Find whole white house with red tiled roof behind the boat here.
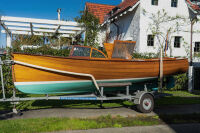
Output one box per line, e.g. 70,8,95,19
85,0,200,90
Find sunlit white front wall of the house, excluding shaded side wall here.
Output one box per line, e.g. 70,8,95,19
138,0,200,56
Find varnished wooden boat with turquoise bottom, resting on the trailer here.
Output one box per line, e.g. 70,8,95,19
13,43,188,94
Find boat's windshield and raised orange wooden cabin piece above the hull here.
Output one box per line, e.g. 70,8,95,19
64,40,136,60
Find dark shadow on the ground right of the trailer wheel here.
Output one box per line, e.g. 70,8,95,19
154,92,200,133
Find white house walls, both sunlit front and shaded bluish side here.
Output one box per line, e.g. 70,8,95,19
104,0,200,57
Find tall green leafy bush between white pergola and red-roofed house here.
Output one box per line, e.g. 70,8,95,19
75,10,100,47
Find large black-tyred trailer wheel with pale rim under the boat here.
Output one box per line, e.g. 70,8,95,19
137,94,154,113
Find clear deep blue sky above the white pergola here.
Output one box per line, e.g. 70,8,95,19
0,0,122,20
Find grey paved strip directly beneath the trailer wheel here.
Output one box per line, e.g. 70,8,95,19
0,104,200,120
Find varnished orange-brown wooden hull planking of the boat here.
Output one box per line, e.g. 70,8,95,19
13,54,188,94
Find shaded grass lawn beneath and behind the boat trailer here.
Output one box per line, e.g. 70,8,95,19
0,91,200,110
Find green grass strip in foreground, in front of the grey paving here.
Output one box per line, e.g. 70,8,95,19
0,114,200,133
